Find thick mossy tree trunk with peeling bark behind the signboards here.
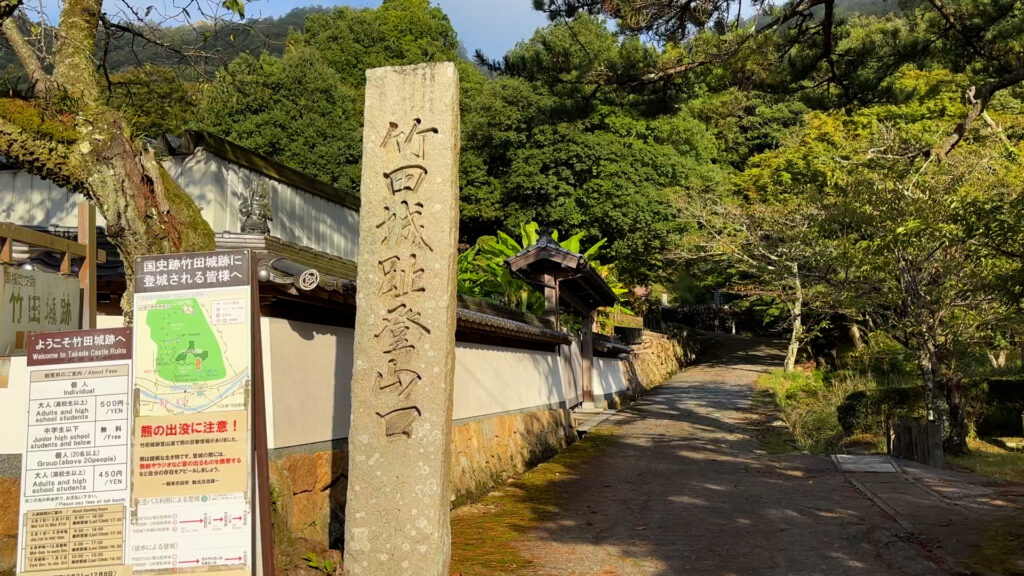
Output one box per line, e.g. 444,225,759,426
0,0,213,323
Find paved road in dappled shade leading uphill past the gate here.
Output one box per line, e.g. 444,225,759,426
521,339,929,576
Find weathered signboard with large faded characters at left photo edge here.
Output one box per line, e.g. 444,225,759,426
0,266,82,356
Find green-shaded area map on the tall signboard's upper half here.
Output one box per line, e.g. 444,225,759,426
135,288,251,416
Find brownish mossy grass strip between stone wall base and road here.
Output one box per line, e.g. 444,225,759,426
452,428,612,576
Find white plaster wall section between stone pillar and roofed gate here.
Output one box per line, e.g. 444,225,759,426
453,343,565,420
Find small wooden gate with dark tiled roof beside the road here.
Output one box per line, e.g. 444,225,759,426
506,232,618,403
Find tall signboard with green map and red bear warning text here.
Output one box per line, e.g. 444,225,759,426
131,250,253,575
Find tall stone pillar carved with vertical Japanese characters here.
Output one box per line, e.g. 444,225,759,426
344,63,460,576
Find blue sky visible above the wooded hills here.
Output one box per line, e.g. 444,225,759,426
246,0,548,58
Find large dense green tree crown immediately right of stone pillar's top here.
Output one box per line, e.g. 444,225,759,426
462,16,724,283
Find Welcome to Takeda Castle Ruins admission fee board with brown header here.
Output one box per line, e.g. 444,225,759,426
17,328,132,576
